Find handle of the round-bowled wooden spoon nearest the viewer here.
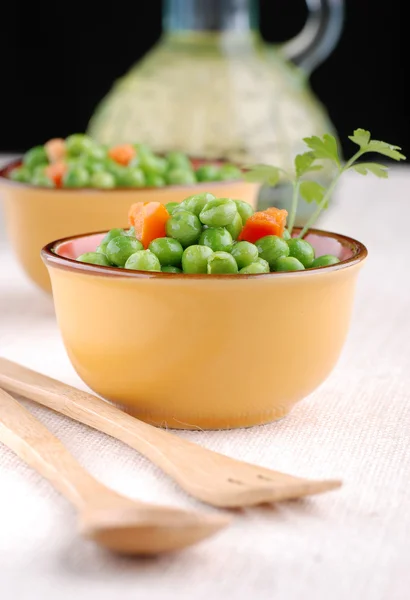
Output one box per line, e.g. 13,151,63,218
0,389,110,509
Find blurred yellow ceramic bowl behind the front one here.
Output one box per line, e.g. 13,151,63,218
0,162,259,291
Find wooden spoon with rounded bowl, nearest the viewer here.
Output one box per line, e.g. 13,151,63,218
0,389,229,554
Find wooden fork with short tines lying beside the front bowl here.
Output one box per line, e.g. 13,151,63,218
0,358,341,507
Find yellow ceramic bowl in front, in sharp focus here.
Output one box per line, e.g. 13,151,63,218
42,231,367,429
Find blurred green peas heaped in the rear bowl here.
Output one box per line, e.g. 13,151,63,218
9,134,242,189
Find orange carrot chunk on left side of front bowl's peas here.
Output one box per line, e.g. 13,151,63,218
128,202,170,248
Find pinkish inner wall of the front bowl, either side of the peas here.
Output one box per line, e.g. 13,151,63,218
54,233,358,261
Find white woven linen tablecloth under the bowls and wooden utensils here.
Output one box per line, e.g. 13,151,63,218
0,167,410,600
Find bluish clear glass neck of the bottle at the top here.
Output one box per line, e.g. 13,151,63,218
164,0,259,34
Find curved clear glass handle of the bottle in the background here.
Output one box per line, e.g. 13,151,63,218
281,0,345,75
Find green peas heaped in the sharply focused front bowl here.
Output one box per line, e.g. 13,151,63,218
77,193,339,275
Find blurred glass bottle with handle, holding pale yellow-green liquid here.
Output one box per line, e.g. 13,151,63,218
89,0,343,222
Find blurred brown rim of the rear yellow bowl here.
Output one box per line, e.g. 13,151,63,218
0,156,253,195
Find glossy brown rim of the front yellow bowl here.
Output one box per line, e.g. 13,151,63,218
41,227,368,281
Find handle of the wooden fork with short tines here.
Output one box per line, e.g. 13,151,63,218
0,358,187,480
